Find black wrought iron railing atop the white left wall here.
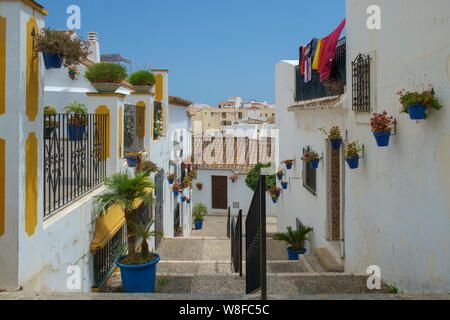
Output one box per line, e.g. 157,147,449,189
43,114,109,216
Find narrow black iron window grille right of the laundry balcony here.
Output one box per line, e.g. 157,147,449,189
352,53,371,112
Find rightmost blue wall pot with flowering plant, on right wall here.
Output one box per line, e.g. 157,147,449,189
397,89,442,120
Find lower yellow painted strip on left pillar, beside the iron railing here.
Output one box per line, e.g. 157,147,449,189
25,132,38,237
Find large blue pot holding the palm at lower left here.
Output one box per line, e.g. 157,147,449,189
116,253,160,293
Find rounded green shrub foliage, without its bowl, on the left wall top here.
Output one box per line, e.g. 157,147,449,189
84,62,127,83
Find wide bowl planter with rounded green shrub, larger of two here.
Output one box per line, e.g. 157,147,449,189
84,62,127,93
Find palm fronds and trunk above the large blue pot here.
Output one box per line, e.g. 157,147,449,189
94,171,154,265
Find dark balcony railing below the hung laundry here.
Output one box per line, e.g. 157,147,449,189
295,38,347,102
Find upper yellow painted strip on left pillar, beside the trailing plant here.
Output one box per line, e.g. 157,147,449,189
26,17,39,122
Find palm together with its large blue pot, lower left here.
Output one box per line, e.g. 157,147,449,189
94,172,160,293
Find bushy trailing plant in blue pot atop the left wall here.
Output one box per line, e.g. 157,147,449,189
34,28,90,69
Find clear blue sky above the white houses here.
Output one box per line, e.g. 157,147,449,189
38,0,345,106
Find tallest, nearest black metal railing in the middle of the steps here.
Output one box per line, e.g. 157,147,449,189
245,176,267,300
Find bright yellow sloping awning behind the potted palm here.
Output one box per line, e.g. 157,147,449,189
91,189,153,251
